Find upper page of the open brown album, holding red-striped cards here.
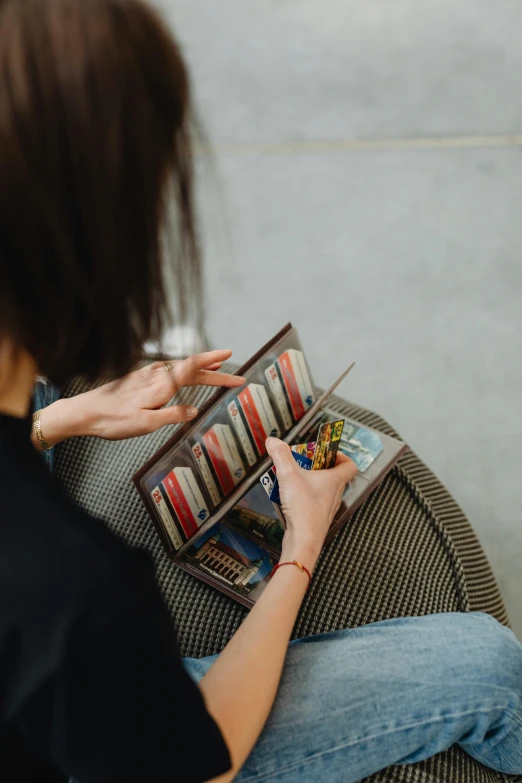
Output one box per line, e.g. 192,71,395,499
133,324,353,561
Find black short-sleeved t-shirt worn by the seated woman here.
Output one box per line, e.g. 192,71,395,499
0,415,230,783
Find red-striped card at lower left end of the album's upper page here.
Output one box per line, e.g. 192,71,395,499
152,468,209,549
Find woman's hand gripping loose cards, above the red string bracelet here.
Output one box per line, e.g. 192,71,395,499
266,438,357,571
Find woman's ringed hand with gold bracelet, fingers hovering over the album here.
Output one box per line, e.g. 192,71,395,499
36,350,245,446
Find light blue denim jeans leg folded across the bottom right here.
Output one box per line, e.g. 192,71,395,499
184,613,522,783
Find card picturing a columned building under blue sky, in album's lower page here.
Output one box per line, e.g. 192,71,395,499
185,523,274,596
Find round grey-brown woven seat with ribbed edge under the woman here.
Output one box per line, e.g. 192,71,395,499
56,380,522,783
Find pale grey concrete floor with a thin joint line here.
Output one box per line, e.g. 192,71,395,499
162,0,522,638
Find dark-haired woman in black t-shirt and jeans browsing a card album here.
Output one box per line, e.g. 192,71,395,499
0,0,522,783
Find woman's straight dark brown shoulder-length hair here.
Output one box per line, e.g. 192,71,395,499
0,0,201,383
